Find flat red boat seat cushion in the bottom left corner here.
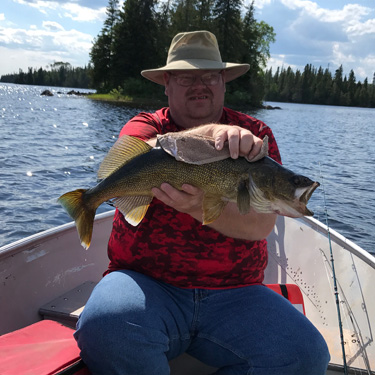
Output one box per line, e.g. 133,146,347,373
0,320,89,375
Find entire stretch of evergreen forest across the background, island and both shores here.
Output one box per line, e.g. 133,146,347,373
0,0,375,108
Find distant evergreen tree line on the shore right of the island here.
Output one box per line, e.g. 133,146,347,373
264,64,375,108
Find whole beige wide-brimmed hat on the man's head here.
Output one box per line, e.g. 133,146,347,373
141,31,250,85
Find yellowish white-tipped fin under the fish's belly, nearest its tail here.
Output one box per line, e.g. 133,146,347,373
113,195,152,226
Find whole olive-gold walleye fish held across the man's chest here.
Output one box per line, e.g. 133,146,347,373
58,132,319,249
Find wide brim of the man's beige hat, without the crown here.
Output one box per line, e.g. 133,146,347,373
141,59,250,86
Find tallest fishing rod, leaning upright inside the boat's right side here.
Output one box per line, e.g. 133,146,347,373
319,163,348,375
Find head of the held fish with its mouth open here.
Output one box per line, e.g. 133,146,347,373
250,158,320,217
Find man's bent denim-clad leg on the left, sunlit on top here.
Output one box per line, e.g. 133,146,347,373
74,273,177,375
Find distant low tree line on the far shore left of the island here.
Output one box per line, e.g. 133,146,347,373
0,62,92,88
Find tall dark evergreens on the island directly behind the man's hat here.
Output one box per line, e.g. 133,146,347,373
90,0,275,106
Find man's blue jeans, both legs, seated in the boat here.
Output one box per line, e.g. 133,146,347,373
75,271,329,375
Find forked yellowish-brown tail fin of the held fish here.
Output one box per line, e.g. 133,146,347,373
57,189,97,250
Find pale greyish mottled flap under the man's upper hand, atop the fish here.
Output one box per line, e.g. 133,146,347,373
157,132,268,165
